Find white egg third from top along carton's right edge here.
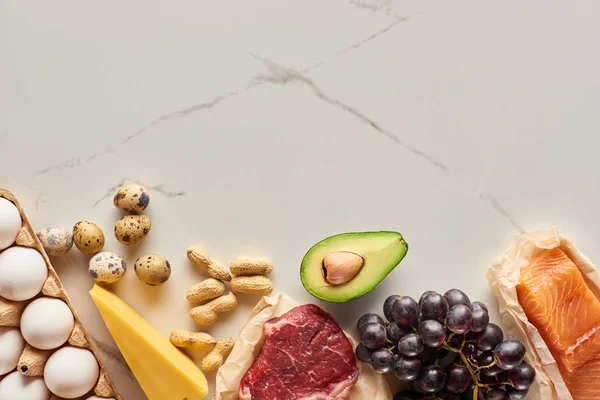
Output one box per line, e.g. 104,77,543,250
21,297,75,350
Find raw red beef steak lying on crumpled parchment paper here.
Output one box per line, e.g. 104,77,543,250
239,304,358,400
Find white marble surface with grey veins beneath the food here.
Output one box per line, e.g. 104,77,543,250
0,0,600,400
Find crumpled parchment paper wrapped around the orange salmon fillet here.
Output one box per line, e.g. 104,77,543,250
486,228,600,400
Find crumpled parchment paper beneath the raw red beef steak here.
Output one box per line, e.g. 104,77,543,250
215,293,392,400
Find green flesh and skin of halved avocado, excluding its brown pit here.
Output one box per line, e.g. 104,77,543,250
300,231,408,303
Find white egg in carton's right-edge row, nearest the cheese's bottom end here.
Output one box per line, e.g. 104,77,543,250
43,346,100,400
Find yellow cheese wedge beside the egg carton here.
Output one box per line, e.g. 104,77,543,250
90,285,208,400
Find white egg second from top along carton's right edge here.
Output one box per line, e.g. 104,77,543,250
0,246,48,301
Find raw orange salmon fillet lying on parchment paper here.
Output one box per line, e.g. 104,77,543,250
517,248,600,400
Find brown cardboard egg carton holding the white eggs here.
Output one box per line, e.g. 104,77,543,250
0,188,123,400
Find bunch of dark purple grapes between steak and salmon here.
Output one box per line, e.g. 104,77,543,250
356,289,535,400
